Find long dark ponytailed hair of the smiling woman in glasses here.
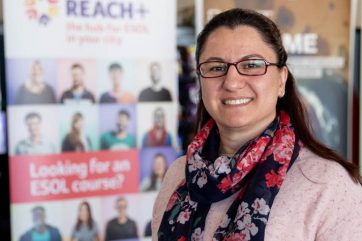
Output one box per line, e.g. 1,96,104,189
196,8,362,184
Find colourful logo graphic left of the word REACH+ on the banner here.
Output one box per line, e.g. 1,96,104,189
24,0,59,25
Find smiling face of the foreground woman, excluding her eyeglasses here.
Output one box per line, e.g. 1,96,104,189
199,26,288,132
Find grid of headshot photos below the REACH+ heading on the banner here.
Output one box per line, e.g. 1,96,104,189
7,59,179,241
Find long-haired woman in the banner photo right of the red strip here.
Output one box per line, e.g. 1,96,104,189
141,153,167,192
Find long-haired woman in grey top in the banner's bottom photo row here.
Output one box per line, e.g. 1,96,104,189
72,201,100,241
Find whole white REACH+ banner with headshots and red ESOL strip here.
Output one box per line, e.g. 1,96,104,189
4,0,180,241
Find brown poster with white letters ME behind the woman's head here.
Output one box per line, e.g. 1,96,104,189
202,0,351,157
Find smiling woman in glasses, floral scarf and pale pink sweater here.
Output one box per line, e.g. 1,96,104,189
152,9,362,241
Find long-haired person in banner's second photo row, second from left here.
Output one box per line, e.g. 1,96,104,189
62,112,92,152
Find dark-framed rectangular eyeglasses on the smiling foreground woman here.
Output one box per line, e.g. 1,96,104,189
197,59,279,78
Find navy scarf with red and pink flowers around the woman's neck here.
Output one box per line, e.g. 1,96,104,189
158,111,301,241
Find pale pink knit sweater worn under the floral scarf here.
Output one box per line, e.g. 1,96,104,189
152,148,362,241
